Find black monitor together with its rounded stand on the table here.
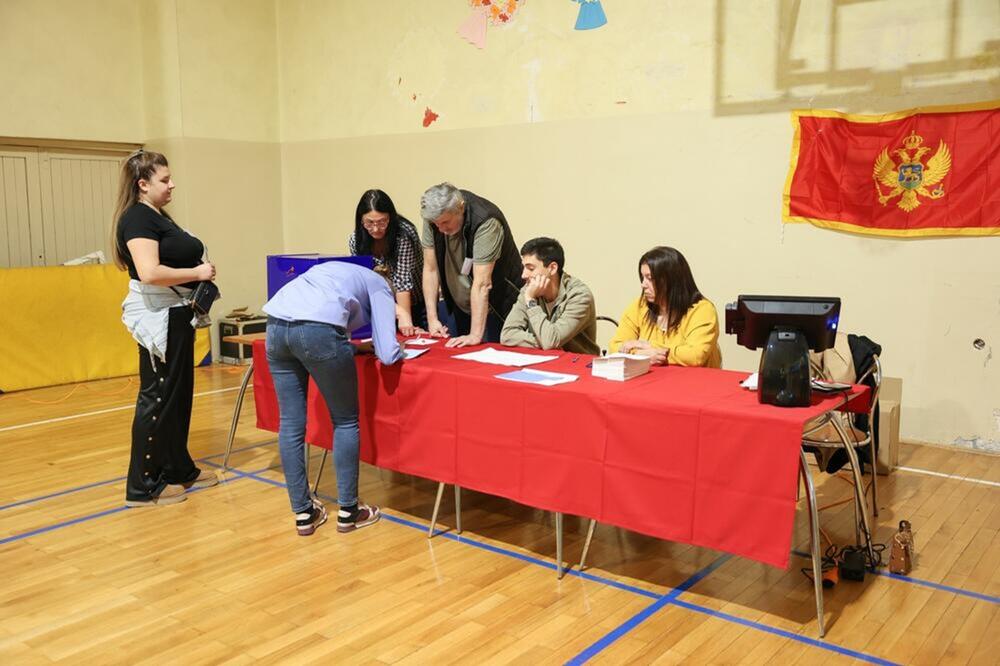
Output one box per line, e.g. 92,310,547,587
726,296,840,407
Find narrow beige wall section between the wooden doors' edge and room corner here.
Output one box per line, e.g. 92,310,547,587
140,0,284,350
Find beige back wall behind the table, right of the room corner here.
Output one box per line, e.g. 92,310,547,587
278,0,1000,449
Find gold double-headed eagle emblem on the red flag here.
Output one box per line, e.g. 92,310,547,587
872,132,951,213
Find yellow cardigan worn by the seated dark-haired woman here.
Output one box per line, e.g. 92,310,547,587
608,296,722,368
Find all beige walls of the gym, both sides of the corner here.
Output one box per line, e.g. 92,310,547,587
0,0,1000,447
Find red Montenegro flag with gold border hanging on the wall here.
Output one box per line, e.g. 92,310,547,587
783,101,1000,236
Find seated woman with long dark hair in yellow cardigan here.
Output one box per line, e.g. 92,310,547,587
608,247,722,368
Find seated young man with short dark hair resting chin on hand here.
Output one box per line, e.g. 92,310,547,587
500,237,601,356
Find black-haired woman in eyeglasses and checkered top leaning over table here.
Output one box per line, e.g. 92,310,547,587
348,190,427,336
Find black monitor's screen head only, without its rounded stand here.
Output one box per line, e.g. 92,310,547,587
726,296,840,352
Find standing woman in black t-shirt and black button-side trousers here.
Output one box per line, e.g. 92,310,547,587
111,150,218,506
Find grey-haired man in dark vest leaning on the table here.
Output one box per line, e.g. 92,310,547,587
420,183,521,347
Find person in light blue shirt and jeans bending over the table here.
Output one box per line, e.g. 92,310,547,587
264,261,403,536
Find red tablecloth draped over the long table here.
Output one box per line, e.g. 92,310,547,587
254,341,867,567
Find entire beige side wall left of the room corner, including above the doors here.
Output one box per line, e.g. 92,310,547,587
0,0,283,349
